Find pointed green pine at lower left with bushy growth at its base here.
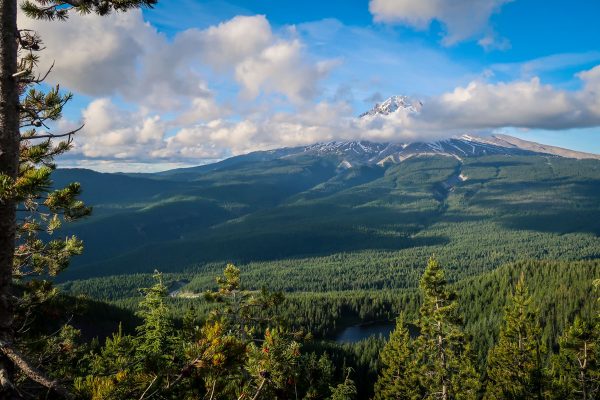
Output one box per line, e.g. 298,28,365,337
75,272,185,400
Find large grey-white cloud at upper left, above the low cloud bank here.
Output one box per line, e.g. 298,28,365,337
19,10,332,108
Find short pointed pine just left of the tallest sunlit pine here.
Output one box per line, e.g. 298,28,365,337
374,314,423,400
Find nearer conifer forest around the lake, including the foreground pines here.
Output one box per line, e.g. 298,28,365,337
12,258,600,399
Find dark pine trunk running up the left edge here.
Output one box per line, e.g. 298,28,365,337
0,0,19,376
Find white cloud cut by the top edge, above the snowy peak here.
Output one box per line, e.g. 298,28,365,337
369,0,512,48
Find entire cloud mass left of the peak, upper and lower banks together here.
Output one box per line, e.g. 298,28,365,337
19,11,335,169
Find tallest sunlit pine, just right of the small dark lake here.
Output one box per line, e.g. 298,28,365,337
416,257,479,400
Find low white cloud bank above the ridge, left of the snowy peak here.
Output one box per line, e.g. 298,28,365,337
67,98,352,164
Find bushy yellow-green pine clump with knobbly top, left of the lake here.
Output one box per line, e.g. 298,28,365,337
193,264,330,399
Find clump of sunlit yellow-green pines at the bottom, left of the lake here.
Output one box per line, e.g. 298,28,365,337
74,265,355,400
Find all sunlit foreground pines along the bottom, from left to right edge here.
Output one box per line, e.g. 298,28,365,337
3,258,600,400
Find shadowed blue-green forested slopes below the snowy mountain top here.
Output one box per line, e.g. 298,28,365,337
56,156,600,282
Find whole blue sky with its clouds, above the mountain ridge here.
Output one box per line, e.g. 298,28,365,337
20,0,600,170
